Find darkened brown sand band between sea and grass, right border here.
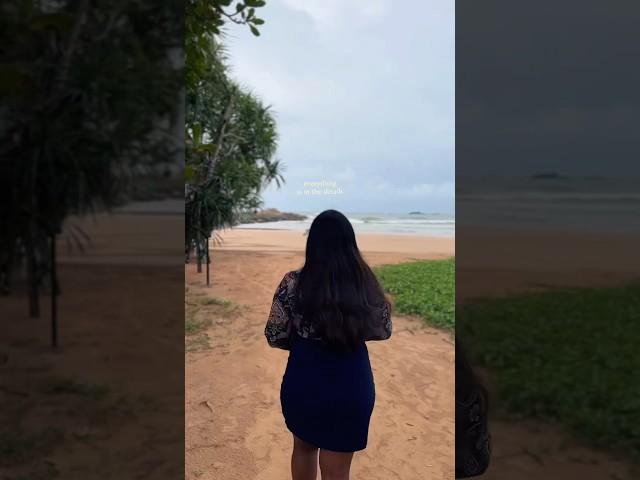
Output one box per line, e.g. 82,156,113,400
456,228,640,303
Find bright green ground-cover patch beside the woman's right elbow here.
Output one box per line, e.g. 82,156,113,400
374,258,455,332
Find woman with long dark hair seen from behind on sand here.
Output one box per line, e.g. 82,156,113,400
265,210,391,480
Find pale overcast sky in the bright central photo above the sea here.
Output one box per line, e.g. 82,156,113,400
225,0,455,213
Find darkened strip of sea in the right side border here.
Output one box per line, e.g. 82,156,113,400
456,175,640,232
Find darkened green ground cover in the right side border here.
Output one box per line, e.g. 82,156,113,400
457,285,640,458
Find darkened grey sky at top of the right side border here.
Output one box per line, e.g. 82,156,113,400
456,0,640,176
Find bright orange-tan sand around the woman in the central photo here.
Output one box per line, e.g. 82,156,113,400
185,230,454,480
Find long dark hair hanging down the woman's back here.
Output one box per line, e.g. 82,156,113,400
296,210,386,350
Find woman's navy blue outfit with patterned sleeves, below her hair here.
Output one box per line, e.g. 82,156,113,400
265,271,391,452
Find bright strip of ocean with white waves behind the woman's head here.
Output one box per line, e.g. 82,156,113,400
235,212,455,237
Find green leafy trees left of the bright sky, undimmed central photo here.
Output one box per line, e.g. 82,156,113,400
185,0,284,266
